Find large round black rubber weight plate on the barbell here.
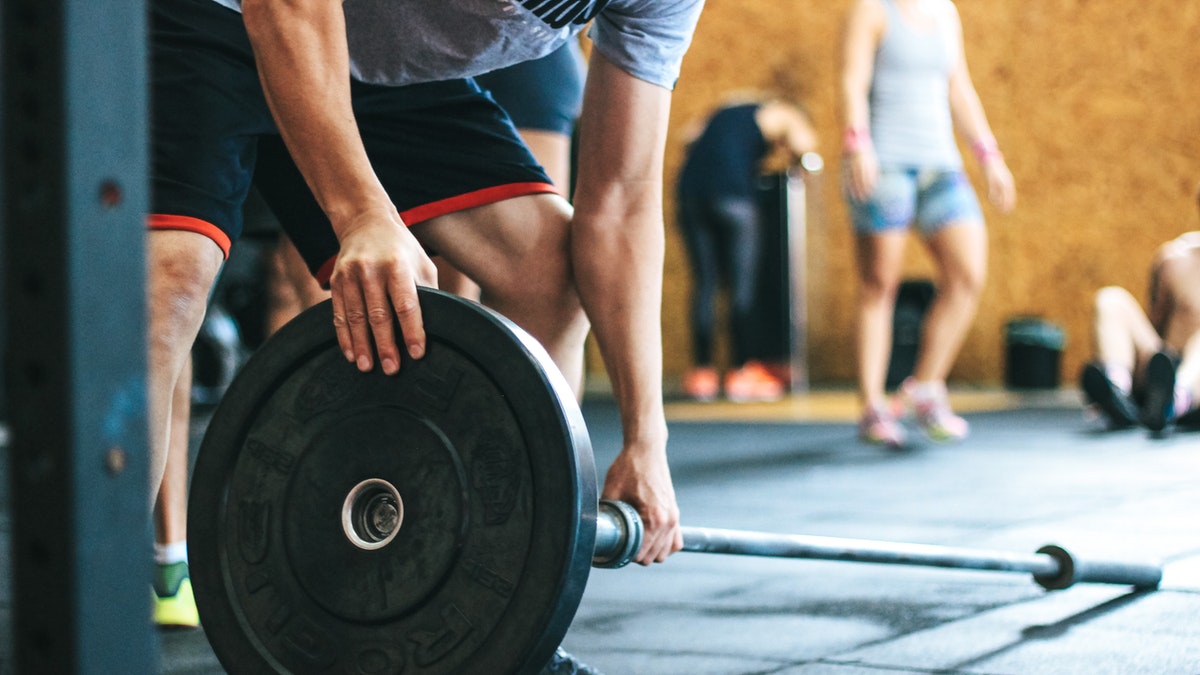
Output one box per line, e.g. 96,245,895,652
187,288,596,675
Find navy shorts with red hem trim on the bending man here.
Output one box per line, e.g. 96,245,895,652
149,0,554,283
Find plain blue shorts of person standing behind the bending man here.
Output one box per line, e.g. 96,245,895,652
475,40,584,136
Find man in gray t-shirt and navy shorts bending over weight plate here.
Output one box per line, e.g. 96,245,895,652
148,0,702,662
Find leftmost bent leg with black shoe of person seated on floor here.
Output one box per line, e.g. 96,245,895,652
1080,286,1163,429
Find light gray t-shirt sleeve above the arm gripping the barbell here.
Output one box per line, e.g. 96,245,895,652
588,0,704,89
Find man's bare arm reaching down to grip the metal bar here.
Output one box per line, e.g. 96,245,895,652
571,50,683,565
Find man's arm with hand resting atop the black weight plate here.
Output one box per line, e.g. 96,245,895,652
242,0,437,374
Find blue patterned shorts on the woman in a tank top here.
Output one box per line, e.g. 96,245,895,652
846,166,983,237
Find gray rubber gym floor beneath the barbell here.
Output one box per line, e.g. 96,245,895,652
0,390,1200,675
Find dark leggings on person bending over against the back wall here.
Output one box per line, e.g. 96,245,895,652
679,198,761,366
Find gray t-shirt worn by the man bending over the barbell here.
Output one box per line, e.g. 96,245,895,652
207,0,704,89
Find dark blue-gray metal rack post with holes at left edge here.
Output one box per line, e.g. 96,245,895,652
0,0,158,674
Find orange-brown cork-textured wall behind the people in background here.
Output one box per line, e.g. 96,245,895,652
628,0,1200,386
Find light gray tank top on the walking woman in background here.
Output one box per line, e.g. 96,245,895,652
870,0,962,168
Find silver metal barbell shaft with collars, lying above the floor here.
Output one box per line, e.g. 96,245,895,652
593,501,1163,590
